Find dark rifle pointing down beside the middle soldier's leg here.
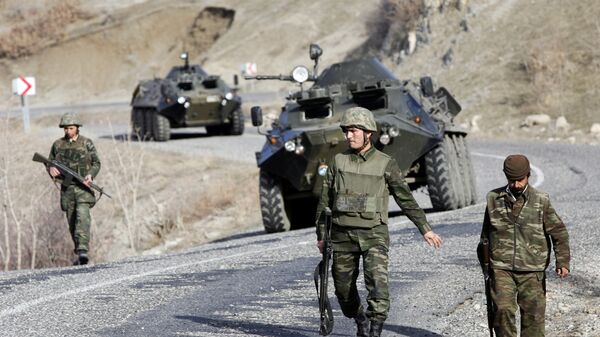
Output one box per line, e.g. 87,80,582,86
314,207,333,336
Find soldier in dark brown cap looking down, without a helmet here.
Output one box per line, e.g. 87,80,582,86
479,155,570,337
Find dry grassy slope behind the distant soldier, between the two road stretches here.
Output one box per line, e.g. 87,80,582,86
0,113,260,270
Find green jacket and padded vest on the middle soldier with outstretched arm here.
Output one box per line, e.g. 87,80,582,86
316,147,431,240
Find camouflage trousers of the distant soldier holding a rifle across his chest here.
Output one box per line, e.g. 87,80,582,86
60,185,96,253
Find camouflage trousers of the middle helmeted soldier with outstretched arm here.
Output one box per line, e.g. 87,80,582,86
331,226,390,322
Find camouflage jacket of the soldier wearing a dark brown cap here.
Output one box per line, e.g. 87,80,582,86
480,185,571,271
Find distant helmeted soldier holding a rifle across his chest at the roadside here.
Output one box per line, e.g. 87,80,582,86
47,113,100,264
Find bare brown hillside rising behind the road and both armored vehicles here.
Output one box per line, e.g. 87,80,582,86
0,0,600,143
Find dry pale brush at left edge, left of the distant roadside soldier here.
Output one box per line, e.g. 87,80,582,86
0,118,73,270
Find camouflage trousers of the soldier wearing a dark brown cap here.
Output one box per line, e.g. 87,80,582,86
491,269,546,337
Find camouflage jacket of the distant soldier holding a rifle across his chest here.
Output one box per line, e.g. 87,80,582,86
48,135,100,178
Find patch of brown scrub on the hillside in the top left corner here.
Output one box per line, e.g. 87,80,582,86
0,1,89,59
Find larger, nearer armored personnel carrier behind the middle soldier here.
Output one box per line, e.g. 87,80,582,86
245,45,477,232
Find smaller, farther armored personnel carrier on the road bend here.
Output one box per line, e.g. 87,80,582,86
131,53,244,141
